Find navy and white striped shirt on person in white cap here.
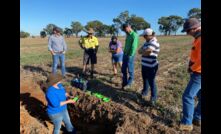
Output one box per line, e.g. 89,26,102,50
141,37,160,68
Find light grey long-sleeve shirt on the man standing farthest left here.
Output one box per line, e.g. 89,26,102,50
48,35,67,52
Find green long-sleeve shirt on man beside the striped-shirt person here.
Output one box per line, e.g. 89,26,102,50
124,31,139,56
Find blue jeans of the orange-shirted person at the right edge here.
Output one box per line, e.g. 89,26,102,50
181,73,201,125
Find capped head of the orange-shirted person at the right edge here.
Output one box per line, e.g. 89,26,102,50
182,18,201,36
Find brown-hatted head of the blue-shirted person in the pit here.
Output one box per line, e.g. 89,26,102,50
46,73,63,87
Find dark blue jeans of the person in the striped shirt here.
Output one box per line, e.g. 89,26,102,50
142,65,158,101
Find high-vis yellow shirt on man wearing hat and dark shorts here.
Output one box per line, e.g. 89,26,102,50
82,36,98,49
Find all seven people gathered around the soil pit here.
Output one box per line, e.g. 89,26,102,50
46,18,201,133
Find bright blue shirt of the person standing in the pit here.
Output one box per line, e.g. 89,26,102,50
45,84,67,115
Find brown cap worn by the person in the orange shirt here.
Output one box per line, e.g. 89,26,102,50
181,18,201,32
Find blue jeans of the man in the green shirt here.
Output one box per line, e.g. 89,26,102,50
121,55,134,87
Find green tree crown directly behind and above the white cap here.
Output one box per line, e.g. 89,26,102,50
128,15,150,31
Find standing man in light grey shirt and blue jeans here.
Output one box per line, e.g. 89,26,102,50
48,27,67,77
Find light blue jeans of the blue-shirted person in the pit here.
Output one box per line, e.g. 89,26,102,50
49,109,76,134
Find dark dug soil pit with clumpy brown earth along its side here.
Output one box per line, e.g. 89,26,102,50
68,90,152,134
